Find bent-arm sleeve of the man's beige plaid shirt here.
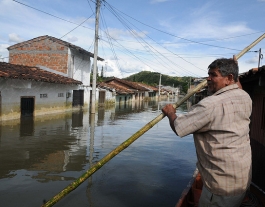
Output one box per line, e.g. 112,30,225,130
174,101,214,137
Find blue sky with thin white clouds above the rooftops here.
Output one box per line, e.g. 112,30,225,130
0,0,265,78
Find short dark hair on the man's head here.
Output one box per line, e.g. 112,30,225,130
208,58,238,82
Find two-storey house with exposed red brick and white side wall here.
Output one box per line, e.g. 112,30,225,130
8,35,104,108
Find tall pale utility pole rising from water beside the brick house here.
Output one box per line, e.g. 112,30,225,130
90,0,100,114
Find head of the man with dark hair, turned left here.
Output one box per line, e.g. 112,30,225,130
207,58,238,93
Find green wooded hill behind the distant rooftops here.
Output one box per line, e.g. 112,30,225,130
123,71,190,93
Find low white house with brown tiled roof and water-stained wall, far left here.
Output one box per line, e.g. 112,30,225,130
0,62,82,121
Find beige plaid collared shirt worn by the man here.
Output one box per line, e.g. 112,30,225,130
174,84,252,196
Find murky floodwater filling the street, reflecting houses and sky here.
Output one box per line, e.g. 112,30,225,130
0,100,196,207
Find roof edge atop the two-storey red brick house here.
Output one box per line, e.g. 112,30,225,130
7,35,104,61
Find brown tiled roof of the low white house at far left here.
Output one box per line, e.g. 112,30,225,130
0,62,82,85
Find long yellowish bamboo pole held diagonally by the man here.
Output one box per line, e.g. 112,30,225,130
42,33,265,207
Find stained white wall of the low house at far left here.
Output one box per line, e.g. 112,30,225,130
0,78,78,120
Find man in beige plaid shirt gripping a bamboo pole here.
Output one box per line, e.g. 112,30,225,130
162,58,252,207
